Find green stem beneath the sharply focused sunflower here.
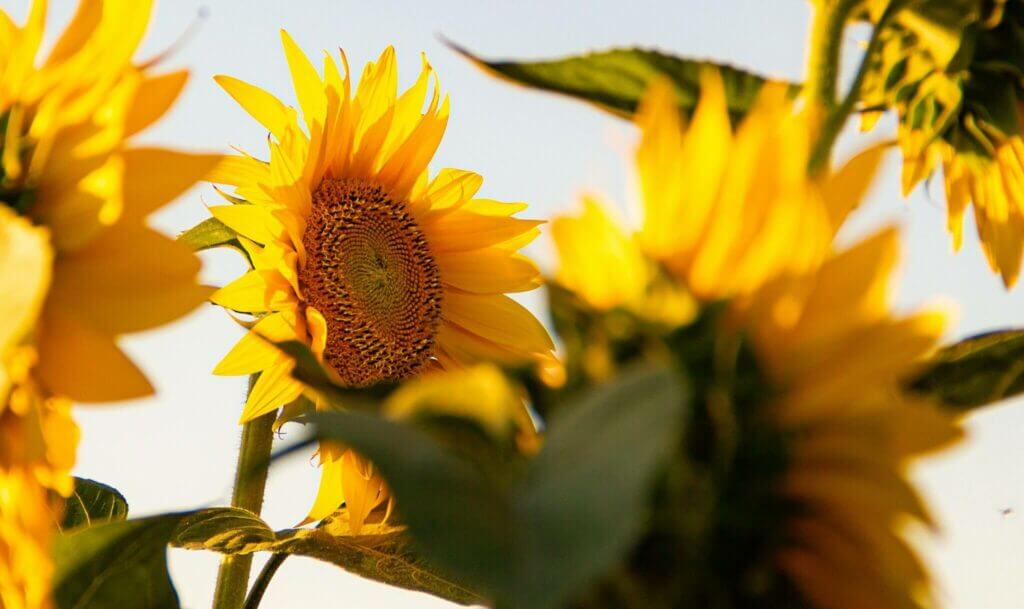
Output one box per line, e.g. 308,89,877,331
213,376,275,609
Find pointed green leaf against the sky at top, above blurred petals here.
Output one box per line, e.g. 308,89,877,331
452,45,800,122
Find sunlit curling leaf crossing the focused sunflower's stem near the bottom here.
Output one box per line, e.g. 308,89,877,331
171,508,482,605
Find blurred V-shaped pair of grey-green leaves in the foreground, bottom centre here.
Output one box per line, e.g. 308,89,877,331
313,369,686,609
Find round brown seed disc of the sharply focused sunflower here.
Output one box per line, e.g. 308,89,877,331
299,179,443,387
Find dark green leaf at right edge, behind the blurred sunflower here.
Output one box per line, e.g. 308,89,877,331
908,330,1024,411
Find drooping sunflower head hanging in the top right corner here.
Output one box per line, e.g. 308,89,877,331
861,0,1024,288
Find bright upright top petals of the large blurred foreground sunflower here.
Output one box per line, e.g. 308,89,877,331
552,70,883,311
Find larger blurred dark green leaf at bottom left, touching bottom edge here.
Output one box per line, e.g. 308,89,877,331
53,514,187,609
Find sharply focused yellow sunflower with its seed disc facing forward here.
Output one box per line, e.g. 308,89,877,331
210,32,553,526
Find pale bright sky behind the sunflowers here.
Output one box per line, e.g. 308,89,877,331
9,0,1024,609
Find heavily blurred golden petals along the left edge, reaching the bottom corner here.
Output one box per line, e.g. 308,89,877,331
0,207,77,609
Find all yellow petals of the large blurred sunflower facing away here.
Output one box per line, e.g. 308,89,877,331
554,73,961,609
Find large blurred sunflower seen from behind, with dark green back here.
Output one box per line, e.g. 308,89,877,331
555,73,961,609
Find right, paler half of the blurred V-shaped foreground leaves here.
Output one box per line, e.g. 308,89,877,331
509,364,687,608
